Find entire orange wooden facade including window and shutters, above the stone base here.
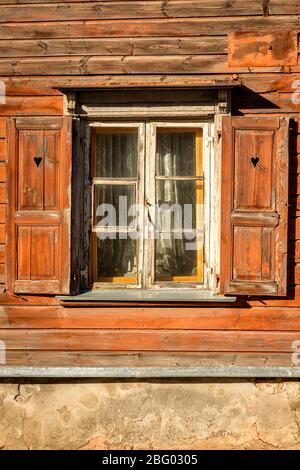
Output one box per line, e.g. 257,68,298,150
0,0,300,376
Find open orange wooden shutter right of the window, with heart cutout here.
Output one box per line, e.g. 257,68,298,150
220,117,289,295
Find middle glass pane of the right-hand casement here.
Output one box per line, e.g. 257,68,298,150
156,180,203,230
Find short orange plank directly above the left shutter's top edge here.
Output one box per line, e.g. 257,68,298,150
0,96,63,116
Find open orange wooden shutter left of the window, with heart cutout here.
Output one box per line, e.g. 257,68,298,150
7,117,71,294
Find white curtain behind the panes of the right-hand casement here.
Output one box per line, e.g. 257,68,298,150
155,132,197,276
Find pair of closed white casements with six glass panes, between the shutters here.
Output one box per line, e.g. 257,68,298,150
90,122,212,289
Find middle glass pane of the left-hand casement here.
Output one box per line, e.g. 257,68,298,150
94,184,135,227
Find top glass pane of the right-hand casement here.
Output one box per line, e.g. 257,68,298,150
156,129,202,176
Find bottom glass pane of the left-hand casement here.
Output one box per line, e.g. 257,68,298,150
95,233,137,282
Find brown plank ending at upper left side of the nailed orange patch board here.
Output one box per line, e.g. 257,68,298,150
0,36,227,57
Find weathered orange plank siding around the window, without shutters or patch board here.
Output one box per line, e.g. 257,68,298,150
0,0,300,366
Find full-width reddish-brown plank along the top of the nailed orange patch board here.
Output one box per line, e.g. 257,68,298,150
0,17,299,40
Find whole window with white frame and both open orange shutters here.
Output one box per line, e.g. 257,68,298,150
6,90,289,301
